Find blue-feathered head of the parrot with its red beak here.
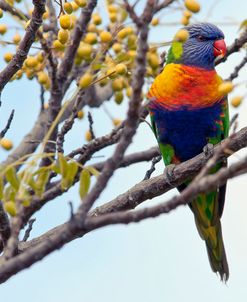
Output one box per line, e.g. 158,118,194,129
170,23,226,70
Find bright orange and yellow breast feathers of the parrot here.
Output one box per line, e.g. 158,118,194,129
148,63,225,109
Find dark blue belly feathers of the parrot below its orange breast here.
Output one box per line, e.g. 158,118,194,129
150,103,222,161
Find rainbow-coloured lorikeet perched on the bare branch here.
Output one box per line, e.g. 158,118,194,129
148,23,229,281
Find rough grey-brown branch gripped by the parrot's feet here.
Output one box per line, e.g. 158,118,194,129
19,127,247,251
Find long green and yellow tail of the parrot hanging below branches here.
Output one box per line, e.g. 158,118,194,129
190,192,229,281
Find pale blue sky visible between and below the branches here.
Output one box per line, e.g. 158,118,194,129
0,0,247,302
